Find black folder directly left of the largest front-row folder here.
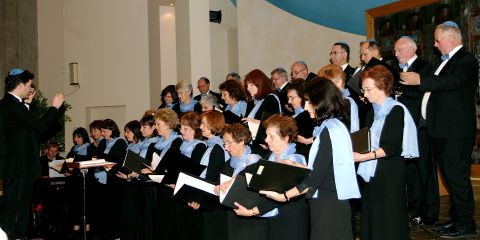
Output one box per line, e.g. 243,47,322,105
221,175,262,209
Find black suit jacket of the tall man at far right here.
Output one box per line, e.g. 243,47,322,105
420,47,478,138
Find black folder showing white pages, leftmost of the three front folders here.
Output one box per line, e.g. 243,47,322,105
173,172,219,210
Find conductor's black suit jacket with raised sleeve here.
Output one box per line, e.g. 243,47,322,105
0,93,61,179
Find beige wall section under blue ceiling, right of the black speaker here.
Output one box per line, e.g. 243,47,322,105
237,0,365,75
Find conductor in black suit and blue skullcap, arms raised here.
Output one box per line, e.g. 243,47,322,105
0,68,64,239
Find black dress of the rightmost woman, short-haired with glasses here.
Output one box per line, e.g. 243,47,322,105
360,106,410,240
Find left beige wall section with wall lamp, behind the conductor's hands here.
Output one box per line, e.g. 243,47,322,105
38,0,150,148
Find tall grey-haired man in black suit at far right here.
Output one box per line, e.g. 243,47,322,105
401,21,478,238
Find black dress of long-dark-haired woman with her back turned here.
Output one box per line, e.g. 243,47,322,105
297,128,352,240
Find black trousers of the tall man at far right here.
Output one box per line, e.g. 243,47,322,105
430,137,476,231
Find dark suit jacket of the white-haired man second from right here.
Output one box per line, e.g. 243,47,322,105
395,58,431,126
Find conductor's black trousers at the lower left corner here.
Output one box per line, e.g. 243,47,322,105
0,178,35,239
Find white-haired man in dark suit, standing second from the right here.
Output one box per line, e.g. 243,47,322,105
394,36,440,225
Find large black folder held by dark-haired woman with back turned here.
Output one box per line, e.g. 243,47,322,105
248,159,311,193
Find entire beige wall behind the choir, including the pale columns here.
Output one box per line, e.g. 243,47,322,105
38,0,364,150
